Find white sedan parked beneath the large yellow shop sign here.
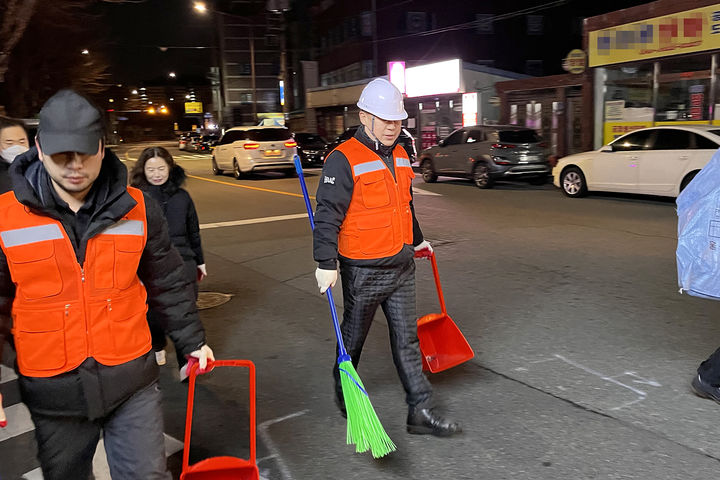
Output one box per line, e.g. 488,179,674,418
553,125,720,197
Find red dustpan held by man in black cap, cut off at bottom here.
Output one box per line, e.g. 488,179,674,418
180,359,260,480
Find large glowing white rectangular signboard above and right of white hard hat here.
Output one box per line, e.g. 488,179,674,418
405,59,462,97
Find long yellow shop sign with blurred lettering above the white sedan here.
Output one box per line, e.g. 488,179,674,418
588,4,720,67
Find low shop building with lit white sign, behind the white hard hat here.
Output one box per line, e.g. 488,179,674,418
306,59,527,144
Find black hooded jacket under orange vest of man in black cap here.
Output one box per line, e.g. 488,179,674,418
0,148,205,418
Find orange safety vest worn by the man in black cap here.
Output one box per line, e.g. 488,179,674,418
0,187,152,377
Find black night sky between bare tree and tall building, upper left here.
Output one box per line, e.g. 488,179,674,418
98,0,214,85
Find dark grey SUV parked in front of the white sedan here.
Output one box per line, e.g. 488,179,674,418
418,125,550,188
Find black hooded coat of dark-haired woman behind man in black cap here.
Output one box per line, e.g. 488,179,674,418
133,165,205,265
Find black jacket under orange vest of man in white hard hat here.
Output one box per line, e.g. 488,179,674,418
313,126,423,270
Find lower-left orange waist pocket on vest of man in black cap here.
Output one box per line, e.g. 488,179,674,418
13,310,67,376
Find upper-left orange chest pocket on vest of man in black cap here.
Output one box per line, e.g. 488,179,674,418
6,240,63,300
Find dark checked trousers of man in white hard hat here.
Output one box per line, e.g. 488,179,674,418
333,261,433,408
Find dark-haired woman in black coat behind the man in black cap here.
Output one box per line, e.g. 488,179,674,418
130,147,207,365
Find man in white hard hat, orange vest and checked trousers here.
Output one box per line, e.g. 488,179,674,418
313,78,461,436
